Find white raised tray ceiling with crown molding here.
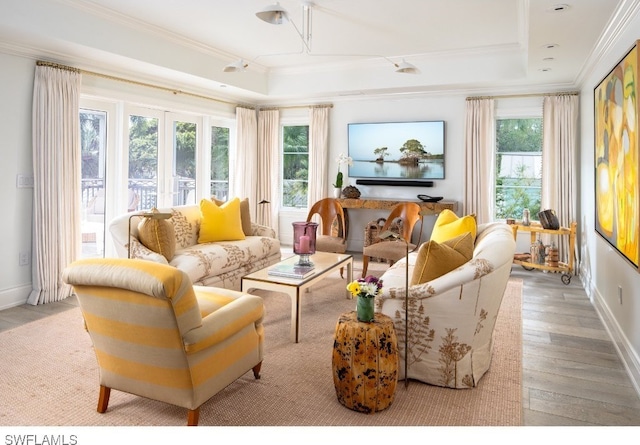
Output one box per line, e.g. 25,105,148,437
0,0,639,103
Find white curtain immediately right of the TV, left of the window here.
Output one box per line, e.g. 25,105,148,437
462,98,496,223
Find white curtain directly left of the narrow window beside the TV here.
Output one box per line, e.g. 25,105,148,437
256,110,280,229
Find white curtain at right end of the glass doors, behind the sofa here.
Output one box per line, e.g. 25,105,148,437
231,107,258,222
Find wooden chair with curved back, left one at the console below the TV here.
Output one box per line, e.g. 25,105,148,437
307,198,347,277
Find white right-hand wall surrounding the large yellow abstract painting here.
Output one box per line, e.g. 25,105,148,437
578,13,640,392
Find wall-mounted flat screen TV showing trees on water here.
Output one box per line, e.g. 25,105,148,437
347,121,444,180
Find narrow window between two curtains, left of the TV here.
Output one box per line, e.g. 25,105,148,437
282,125,309,208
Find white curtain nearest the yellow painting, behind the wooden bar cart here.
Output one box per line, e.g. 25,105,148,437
541,94,579,258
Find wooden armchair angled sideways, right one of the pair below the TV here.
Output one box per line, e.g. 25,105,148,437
362,202,422,278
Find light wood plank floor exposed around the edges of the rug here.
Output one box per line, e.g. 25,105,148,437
0,266,640,426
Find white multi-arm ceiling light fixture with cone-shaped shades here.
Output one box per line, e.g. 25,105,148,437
224,1,420,74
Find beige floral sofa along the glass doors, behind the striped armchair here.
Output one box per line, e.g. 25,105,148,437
109,204,281,290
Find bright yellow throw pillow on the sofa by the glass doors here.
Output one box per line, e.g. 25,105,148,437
198,198,245,243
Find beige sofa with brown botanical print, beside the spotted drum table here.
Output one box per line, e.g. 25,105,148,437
376,223,516,388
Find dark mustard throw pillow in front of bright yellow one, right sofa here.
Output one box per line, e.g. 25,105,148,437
411,232,474,285
